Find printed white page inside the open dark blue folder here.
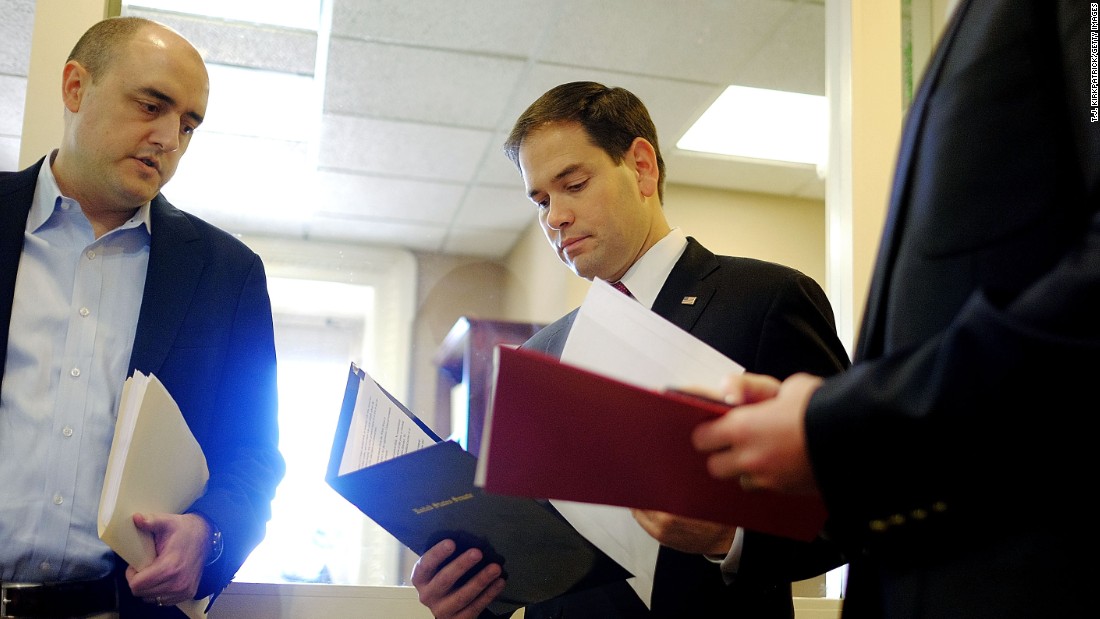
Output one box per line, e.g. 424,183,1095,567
340,368,436,475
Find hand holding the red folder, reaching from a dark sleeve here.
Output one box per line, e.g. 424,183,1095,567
692,374,822,494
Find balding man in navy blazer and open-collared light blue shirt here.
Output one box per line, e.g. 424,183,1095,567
0,18,284,619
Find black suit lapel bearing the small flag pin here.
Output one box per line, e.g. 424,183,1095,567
653,236,718,331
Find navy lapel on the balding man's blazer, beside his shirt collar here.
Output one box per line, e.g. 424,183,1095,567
130,195,204,373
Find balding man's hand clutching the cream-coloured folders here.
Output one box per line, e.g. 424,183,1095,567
127,513,211,606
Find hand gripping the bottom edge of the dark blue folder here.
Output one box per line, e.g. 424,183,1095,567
411,540,505,619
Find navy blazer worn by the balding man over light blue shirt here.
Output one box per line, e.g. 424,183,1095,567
0,161,284,619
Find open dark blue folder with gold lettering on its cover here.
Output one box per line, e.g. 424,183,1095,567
326,364,631,615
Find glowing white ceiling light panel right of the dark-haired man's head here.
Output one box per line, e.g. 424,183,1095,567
677,86,828,166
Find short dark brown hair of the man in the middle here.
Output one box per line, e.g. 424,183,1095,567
504,81,664,202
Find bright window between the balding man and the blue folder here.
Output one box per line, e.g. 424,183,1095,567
237,239,416,585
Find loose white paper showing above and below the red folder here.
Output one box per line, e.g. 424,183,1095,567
551,279,745,607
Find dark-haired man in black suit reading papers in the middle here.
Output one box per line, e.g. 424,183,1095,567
413,81,848,619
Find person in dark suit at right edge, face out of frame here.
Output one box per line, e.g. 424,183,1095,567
693,0,1100,619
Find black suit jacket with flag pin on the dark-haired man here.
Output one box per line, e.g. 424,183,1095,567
524,237,848,619
